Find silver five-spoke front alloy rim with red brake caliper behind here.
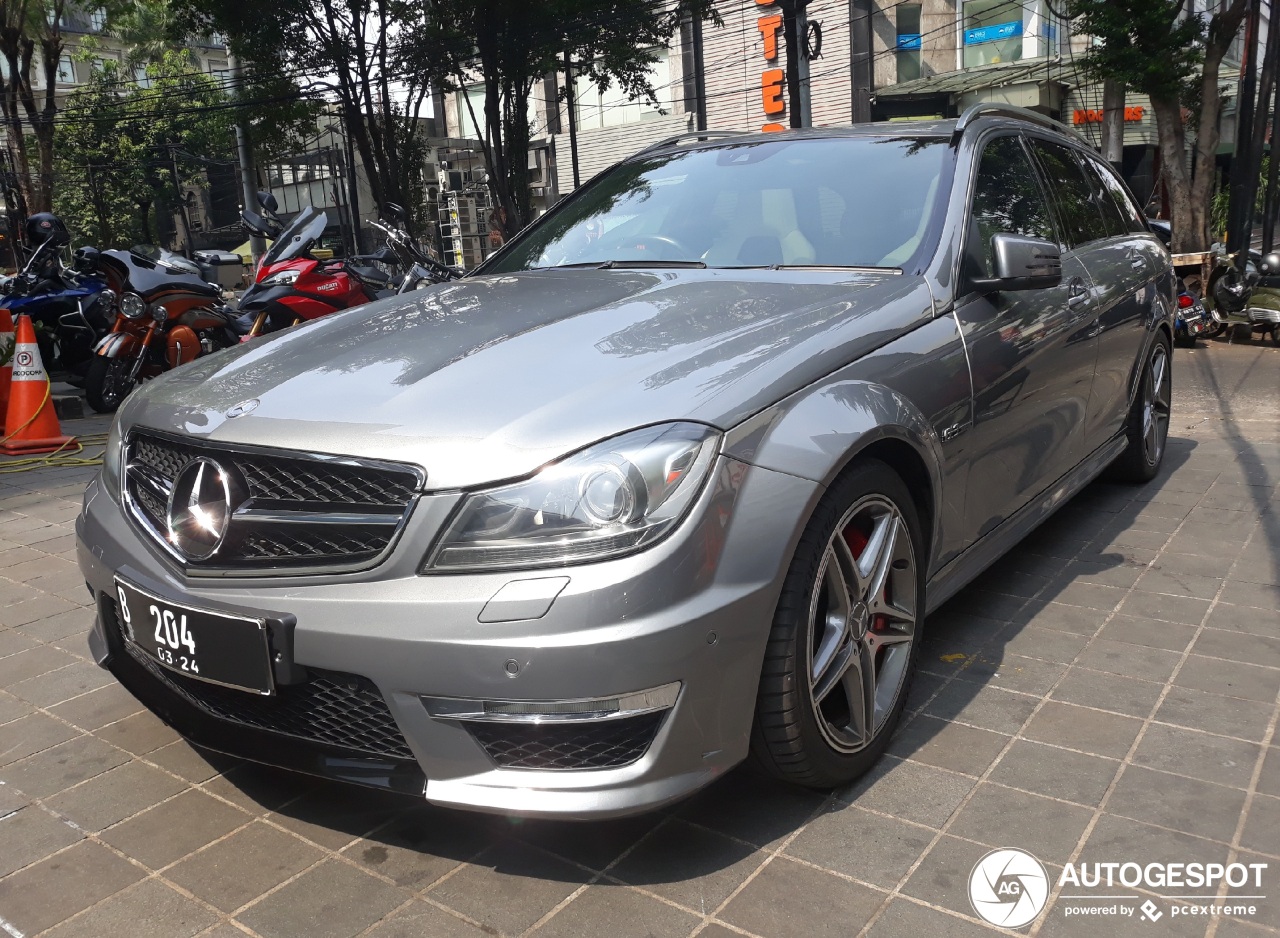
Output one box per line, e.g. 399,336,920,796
808,495,916,752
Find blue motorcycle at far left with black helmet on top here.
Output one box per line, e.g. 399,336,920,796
0,212,115,383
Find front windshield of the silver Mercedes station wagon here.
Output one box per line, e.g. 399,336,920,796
485,137,950,273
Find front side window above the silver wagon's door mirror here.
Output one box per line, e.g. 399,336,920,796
968,137,1057,278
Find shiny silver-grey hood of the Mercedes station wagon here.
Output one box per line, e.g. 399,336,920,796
122,270,932,489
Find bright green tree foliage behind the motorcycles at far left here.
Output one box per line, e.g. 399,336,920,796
54,52,234,247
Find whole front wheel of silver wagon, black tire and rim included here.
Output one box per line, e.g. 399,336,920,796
751,459,927,788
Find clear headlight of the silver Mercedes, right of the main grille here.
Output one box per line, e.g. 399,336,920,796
424,424,719,572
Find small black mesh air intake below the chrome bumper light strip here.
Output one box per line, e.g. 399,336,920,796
463,711,666,770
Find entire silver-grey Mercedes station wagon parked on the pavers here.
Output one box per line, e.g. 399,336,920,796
77,106,1175,818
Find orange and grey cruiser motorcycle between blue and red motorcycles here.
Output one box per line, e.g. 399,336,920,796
84,241,247,413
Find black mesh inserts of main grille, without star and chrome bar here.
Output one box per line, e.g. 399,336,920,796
127,433,417,568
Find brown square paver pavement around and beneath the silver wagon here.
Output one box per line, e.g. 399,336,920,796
0,342,1280,938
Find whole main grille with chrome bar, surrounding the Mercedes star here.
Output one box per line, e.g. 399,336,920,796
125,430,420,576
